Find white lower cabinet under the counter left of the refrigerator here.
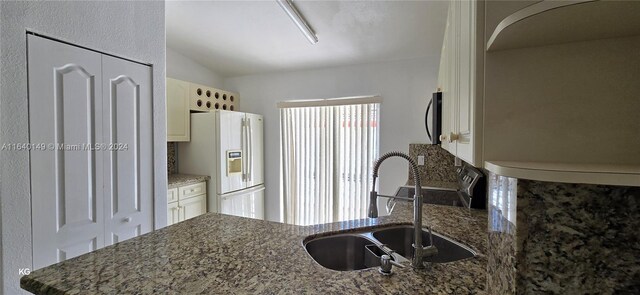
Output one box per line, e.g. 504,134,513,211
167,181,207,225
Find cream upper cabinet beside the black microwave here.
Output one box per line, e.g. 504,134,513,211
438,1,484,166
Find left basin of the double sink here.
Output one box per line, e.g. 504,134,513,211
304,234,379,271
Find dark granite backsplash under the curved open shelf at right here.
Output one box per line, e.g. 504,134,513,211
487,175,640,294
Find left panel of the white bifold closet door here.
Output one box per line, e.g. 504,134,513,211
27,35,104,269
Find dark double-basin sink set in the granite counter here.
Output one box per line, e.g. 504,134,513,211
303,225,476,271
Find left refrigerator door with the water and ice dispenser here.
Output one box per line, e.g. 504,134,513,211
216,111,247,194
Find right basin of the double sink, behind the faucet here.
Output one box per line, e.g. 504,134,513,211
373,225,476,263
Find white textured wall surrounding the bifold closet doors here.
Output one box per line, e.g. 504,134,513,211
0,1,167,294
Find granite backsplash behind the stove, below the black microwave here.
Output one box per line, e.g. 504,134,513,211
407,143,458,189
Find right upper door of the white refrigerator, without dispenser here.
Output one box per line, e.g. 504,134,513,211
245,113,264,187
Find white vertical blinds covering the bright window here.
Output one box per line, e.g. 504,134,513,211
280,103,380,225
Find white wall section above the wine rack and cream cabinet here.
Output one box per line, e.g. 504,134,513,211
167,47,223,88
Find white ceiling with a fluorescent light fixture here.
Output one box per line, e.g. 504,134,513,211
166,0,447,77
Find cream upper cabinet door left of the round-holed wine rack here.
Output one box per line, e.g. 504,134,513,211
167,78,191,141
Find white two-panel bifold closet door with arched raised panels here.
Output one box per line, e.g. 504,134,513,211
28,35,153,269
